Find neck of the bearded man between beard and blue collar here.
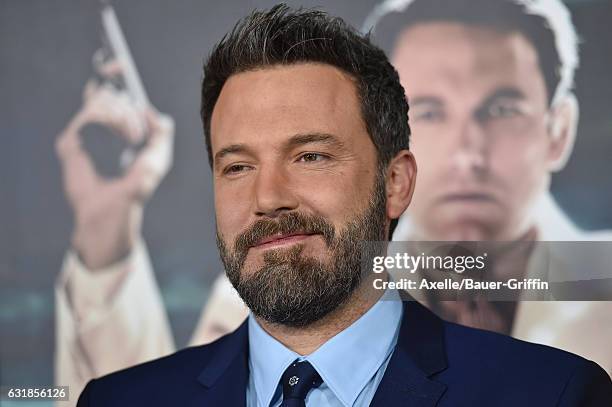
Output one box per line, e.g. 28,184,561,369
255,274,387,355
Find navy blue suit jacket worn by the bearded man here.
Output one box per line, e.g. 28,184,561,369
78,301,612,407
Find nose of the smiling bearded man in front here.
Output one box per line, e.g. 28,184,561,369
254,166,298,218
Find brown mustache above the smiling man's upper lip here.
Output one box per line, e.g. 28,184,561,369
234,212,335,253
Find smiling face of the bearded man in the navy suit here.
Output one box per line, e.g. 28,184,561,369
211,64,386,326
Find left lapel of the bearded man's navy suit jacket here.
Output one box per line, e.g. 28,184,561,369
193,321,249,407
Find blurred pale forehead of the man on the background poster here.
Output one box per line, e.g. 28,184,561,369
392,22,546,104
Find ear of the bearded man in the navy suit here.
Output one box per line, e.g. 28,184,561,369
386,150,417,219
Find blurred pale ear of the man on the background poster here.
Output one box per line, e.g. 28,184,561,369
548,93,579,172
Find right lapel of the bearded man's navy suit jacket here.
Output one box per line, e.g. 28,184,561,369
370,300,446,407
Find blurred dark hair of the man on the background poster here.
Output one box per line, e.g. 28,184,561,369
368,0,573,103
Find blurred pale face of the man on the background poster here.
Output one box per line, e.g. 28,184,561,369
392,23,551,240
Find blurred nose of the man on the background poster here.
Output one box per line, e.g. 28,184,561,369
451,120,490,176
